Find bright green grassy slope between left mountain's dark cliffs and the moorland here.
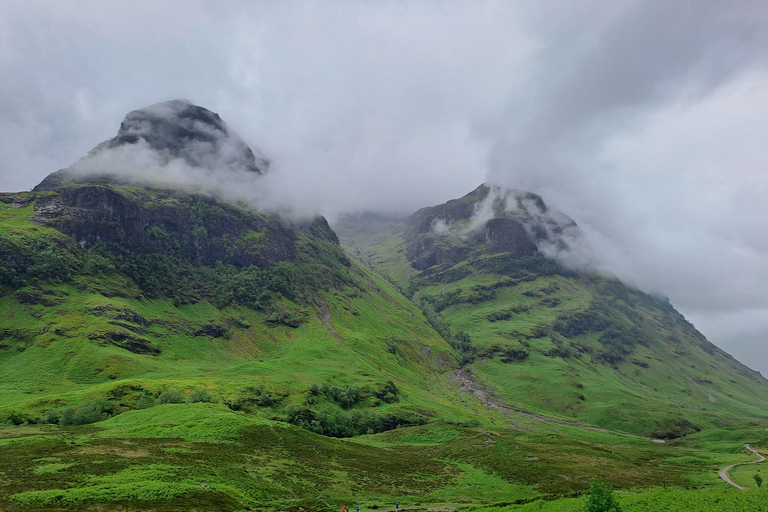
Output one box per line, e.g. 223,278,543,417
0,192,462,420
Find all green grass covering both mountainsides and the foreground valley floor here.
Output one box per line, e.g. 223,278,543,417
0,187,768,511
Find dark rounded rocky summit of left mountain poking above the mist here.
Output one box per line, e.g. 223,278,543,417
104,100,269,174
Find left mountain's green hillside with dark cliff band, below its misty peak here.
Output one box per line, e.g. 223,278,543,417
0,185,472,436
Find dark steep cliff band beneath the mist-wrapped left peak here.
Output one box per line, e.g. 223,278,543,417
25,184,302,267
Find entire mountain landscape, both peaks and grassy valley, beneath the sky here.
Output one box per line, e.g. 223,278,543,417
0,101,768,512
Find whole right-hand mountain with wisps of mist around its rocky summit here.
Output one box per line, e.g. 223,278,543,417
336,185,768,439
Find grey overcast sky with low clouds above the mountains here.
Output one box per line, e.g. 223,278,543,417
0,0,768,376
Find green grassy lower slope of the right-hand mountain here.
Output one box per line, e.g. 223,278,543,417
419,270,766,434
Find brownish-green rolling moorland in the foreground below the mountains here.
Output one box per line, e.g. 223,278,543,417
0,404,768,510
